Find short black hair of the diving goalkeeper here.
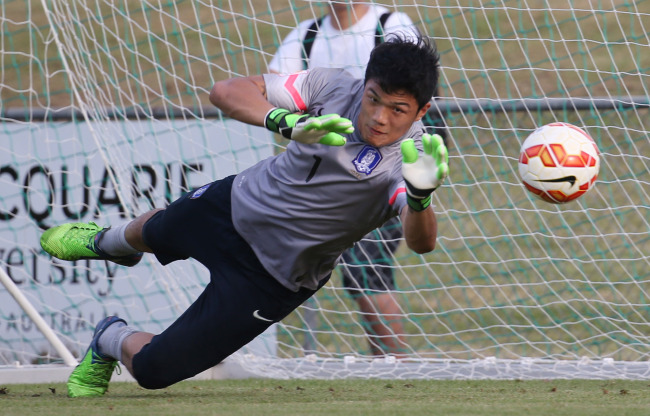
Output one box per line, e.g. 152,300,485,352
364,34,440,109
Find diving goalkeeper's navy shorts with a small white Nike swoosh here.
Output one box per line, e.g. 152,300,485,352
133,176,327,389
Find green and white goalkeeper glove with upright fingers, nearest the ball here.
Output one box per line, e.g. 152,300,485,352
401,134,449,211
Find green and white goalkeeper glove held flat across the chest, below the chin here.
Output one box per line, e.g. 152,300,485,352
264,108,354,146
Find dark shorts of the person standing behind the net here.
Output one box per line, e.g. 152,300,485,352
341,217,402,297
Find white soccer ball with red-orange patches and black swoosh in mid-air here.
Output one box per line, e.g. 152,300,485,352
519,123,600,204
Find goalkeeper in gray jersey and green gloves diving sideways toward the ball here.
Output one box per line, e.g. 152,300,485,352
41,36,448,397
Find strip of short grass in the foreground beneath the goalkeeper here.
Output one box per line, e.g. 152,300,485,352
0,379,650,416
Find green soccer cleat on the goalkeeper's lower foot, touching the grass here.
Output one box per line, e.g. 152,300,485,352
68,316,126,397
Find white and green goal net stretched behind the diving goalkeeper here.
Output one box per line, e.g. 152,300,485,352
0,0,650,378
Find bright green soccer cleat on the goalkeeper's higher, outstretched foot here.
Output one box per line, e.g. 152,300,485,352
41,222,142,267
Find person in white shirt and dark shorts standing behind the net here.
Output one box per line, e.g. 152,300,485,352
268,1,430,357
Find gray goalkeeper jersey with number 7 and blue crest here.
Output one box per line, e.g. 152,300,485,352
232,68,424,291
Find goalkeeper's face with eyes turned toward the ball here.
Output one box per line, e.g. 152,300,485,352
357,79,431,147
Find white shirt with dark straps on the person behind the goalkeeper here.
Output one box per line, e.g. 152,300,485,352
269,6,418,78
